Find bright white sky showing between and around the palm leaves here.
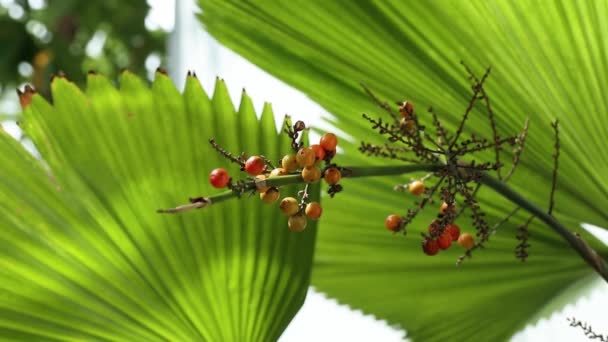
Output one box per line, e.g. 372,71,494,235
0,0,608,342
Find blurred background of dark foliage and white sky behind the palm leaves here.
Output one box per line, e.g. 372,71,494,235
0,0,608,341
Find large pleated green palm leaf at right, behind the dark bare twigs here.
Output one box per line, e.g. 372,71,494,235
200,1,608,341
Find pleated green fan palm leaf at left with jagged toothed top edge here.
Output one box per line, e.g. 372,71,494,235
0,73,318,341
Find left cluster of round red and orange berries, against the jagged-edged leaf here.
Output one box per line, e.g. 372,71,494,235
209,121,342,232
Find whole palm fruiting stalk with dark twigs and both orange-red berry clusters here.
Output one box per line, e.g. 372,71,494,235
159,66,608,281
